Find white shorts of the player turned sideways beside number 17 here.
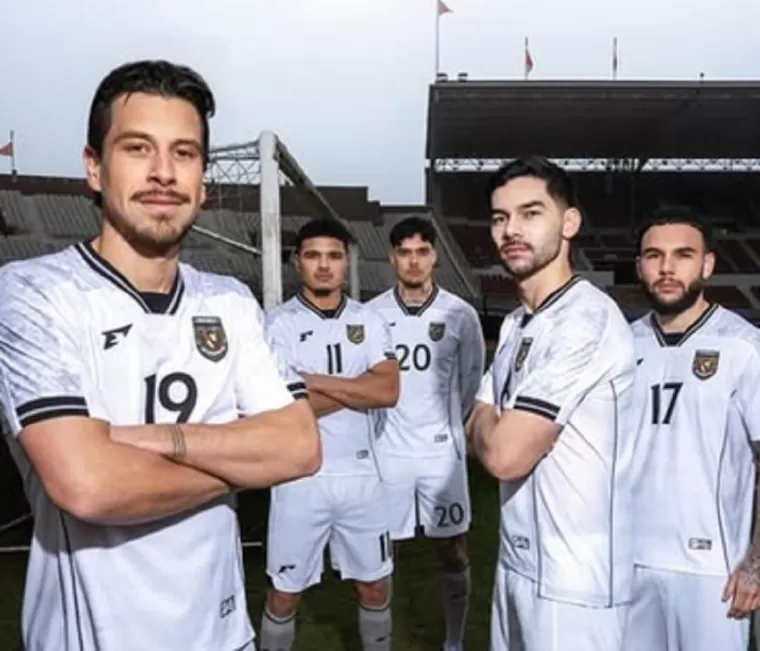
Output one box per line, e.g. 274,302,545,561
490,563,632,651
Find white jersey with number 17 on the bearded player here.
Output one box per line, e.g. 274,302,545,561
633,305,760,576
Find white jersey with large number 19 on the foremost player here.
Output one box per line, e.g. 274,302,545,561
0,244,305,651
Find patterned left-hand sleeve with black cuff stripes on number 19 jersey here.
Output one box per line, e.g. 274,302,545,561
0,273,90,436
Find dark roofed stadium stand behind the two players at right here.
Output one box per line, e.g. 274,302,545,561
427,80,760,321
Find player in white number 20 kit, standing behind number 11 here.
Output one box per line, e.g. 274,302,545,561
369,217,485,651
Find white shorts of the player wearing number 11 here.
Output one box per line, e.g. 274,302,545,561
267,476,393,593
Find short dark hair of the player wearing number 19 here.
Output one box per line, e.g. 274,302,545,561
87,61,216,166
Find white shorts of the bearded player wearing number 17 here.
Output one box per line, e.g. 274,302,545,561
624,567,750,651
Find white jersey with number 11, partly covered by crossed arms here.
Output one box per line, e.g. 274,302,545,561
266,294,395,476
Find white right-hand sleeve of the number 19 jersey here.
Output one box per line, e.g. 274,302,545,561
235,295,306,416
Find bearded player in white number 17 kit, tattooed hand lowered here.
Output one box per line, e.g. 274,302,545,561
626,207,760,651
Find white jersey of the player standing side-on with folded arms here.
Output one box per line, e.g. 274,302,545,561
478,277,636,607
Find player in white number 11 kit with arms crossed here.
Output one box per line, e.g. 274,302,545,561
261,220,399,651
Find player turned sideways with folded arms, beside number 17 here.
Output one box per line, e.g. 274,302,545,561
467,158,636,651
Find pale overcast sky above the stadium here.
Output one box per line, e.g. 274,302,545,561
0,0,760,203
